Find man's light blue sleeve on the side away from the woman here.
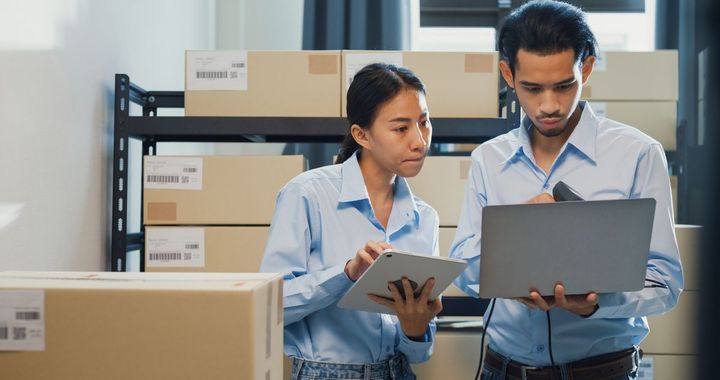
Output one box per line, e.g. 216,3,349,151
589,144,684,318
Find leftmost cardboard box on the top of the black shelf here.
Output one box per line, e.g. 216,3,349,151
185,50,340,117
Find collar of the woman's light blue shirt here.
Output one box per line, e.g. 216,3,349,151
339,151,420,222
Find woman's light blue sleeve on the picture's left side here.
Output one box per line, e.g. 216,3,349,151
260,183,352,326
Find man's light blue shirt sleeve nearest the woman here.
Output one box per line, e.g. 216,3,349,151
448,155,487,297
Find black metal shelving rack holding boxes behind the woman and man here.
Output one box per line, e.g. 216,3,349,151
109,74,520,315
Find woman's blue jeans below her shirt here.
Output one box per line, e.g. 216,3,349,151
290,354,416,380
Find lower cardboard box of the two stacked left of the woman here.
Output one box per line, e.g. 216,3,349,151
145,226,270,273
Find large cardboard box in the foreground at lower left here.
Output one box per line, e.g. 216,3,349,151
0,272,283,380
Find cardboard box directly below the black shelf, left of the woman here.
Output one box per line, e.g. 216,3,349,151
143,156,305,225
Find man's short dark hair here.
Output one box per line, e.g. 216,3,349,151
497,0,597,75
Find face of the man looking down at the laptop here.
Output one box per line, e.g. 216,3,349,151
500,49,595,137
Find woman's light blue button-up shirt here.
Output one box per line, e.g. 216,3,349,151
260,151,439,364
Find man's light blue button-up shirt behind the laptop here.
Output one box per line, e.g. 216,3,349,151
450,102,683,366
